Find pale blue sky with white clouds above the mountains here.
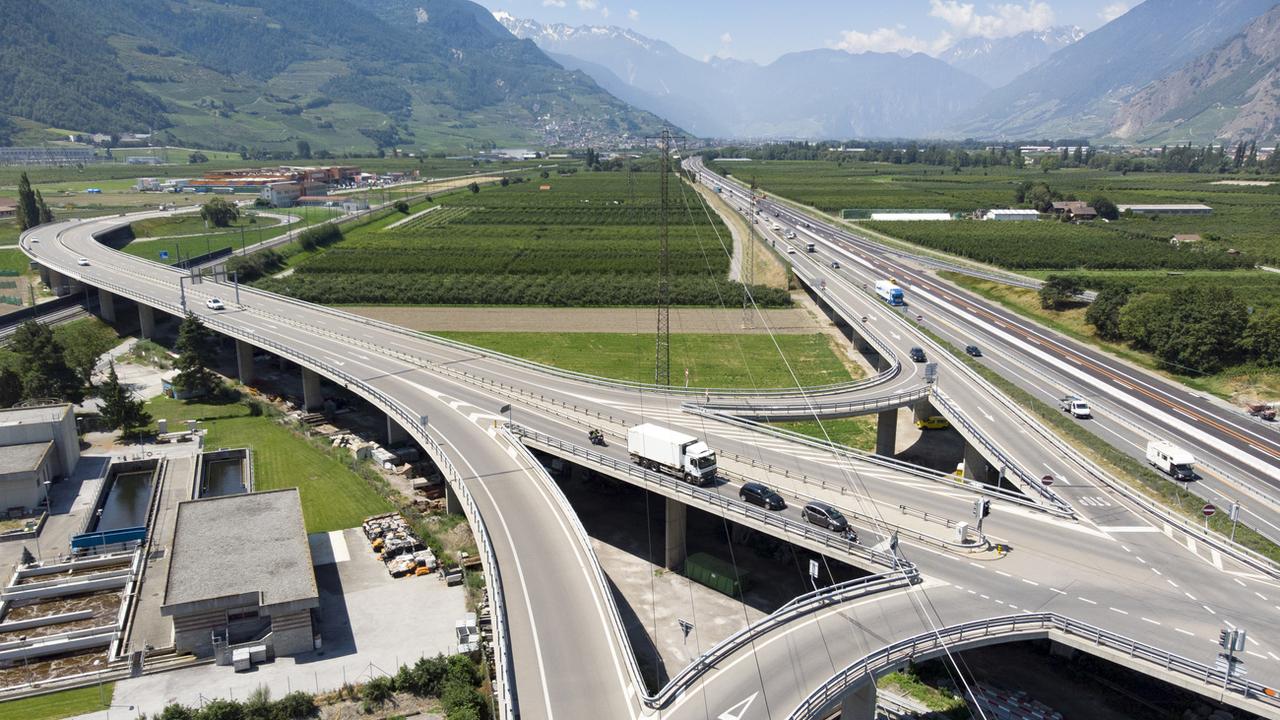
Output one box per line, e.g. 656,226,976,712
479,0,1139,63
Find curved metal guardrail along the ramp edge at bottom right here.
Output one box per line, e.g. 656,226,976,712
788,612,1280,720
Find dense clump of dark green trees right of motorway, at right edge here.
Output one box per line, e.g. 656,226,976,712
1041,275,1280,374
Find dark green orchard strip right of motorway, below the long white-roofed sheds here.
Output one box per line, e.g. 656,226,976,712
860,220,1253,270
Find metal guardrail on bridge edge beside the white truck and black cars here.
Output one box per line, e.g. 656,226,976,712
507,424,915,570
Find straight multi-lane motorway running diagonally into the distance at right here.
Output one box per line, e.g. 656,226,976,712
689,158,1280,541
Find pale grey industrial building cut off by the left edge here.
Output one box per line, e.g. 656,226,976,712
0,404,79,516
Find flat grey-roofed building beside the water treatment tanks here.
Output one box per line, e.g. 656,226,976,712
160,488,320,664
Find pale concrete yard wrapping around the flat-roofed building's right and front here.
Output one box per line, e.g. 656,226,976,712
99,528,466,719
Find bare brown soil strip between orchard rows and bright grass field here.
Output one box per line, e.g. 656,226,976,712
344,306,823,334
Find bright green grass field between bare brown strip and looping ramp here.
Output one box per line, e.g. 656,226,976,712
435,332,851,388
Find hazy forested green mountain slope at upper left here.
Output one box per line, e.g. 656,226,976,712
0,0,663,152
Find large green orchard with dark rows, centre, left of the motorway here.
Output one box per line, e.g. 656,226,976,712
259,173,790,306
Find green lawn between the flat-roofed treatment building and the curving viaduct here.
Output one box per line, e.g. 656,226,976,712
147,389,393,533
